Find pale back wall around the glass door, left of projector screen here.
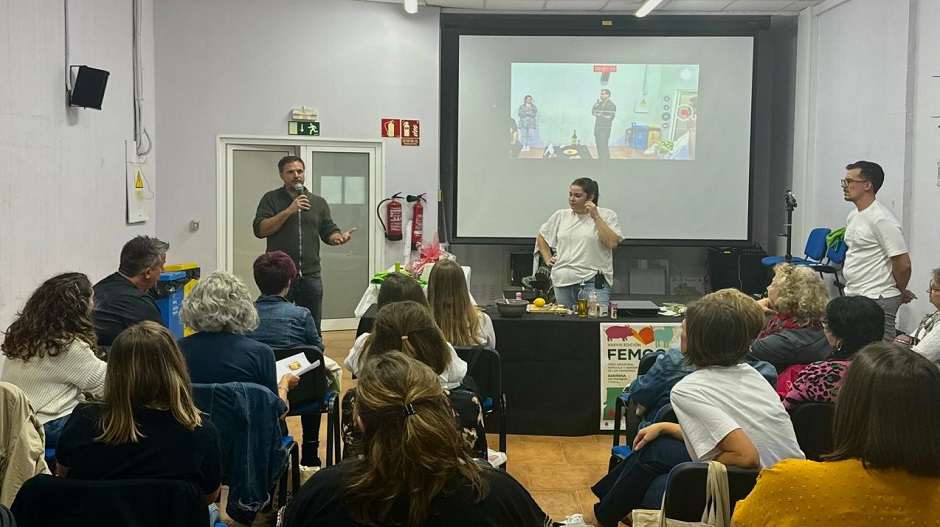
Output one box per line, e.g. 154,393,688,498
154,0,440,270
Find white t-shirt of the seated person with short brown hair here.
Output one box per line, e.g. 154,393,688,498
669,363,806,467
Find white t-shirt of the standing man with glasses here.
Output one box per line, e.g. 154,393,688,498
842,200,907,299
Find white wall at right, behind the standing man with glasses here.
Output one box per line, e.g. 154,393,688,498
794,0,940,330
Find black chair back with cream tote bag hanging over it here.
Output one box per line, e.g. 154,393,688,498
663,462,760,522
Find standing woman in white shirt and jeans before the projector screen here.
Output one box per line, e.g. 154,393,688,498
536,178,623,306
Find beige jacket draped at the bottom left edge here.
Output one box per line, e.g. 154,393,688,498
0,382,49,510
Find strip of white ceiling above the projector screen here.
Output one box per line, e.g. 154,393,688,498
362,0,823,15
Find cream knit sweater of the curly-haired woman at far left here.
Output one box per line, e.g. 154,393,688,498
0,339,107,424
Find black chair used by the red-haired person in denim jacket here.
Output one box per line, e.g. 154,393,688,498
274,346,342,466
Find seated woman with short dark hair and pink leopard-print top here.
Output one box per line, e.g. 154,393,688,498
783,296,885,409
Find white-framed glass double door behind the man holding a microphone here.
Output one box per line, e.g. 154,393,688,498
218,137,384,330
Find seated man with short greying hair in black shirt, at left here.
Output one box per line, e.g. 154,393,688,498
95,236,170,346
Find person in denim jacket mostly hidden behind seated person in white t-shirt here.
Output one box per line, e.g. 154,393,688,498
629,289,777,428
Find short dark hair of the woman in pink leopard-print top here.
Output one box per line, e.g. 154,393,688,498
826,296,885,360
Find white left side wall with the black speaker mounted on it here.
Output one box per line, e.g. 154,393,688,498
0,0,156,330
